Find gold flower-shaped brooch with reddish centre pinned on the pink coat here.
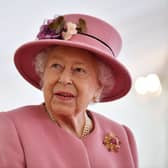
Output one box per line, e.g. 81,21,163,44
103,133,121,152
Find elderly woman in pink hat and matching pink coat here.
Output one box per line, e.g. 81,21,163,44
0,14,138,168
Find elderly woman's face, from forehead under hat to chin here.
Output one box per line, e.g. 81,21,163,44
42,46,101,116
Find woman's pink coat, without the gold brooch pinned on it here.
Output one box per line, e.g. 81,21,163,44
0,105,138,168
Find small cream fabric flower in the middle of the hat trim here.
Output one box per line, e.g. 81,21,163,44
62,22,78,40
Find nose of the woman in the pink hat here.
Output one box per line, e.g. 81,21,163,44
58,70,72,85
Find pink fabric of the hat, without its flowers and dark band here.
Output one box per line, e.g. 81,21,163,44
14,14,131,102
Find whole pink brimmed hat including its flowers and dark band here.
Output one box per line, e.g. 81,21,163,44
14,14,131,102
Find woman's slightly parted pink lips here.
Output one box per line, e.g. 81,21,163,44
54,91,75,101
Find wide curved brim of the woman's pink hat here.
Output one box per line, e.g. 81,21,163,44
14,37,131,102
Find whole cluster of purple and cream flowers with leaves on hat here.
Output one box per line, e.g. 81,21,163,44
37,16,87,40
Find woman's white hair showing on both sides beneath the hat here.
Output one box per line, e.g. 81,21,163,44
34,46,114,102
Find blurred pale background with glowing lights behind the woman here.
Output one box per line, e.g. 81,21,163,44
0,0,168,168
